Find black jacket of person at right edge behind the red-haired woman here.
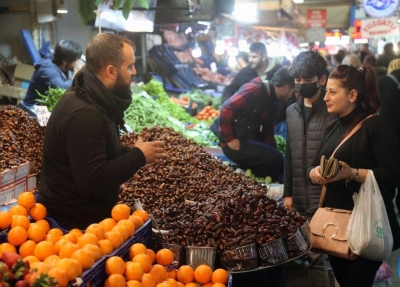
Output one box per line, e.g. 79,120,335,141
378,70,400,151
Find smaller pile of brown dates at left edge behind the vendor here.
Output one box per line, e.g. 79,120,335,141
0,106,44,173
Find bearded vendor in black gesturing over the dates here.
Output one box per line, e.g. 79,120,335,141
37,33,166,229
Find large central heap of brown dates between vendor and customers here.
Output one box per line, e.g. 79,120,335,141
120,127,306,250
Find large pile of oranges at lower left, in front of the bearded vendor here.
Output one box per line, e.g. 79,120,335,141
0,196,152,287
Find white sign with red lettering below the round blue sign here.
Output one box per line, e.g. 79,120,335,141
361,17,399,39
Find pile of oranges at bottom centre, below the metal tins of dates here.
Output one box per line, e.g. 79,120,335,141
105,243,229,287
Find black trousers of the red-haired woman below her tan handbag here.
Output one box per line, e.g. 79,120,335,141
328,256,382,287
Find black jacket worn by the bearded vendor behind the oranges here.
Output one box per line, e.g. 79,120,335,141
38,67,145,229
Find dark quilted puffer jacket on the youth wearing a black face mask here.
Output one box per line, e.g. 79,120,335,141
283,93,336,215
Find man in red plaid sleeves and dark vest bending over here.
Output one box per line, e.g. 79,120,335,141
211,67,294,182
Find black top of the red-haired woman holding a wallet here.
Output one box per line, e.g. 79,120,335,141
310,116,400,250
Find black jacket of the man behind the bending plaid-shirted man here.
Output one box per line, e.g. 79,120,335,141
222,61,282,103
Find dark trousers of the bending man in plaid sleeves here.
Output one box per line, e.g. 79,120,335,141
222,141,284,182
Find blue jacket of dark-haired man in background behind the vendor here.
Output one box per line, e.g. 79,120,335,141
24,58,72,106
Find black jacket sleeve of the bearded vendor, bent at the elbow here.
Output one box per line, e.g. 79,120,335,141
62,109,146,197
